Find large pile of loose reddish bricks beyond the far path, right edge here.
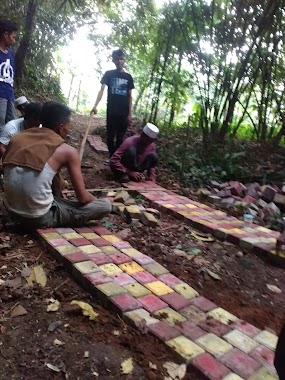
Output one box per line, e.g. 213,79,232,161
198,181,285,227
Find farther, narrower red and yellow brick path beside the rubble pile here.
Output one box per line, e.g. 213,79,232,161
123,182,285,265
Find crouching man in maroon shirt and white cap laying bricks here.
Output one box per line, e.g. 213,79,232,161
110,123,159,182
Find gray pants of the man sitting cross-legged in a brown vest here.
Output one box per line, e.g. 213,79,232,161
12,197,112,230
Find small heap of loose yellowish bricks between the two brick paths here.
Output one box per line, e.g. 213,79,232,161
107,190,160,227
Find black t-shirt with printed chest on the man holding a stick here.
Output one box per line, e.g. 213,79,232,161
101,70,134,116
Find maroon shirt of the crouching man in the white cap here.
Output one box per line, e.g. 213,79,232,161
110,135,155,180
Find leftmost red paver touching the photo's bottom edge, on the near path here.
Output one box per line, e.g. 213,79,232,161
191,354,230,380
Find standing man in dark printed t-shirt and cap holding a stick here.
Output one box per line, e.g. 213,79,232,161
90,50,134,157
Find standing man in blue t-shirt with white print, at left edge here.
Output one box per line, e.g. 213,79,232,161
0,20,18,132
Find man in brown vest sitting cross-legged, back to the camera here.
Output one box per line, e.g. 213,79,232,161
3,102,111,229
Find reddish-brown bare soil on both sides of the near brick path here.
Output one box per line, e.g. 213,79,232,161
0,116,285,380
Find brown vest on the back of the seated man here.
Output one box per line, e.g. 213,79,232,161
2,128,65,172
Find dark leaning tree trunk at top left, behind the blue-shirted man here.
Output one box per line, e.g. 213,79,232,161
15,0,38,83
